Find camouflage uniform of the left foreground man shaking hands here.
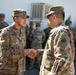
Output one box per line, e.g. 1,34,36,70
0,25,26,75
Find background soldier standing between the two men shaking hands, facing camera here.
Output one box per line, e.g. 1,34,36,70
30,23,45,69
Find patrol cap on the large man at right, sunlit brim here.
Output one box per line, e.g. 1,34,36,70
46,6,64,18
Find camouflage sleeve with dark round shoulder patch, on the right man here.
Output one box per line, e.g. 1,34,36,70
51,31,70,75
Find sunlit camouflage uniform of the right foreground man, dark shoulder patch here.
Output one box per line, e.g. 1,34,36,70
40,26,74,75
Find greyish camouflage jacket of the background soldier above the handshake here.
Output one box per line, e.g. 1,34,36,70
30,30,45,49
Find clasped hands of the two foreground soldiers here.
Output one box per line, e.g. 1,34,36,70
24,49,37,59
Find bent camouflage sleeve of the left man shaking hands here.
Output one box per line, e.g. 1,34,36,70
0,32,24,60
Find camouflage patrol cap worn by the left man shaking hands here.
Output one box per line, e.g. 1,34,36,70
12,9,29,18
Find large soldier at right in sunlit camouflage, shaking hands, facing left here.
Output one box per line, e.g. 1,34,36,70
32,6,74,75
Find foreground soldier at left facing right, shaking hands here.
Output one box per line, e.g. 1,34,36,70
0,9,36,75
